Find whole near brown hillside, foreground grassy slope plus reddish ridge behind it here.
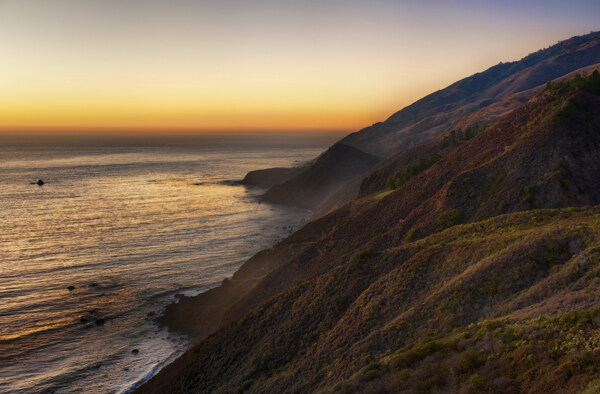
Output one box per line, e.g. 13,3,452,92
140,66,600,393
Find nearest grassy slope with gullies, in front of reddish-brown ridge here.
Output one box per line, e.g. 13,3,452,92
143,208,600,392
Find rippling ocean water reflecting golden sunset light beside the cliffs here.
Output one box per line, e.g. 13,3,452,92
0,135,339,393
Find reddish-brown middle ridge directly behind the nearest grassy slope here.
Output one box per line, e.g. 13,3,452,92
199,73,600,336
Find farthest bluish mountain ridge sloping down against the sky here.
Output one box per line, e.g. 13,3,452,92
341,32,600,157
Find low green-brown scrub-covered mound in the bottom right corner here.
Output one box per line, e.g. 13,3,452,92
332,308,600,393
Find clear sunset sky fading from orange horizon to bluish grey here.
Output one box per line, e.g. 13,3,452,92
0,0,600,132
